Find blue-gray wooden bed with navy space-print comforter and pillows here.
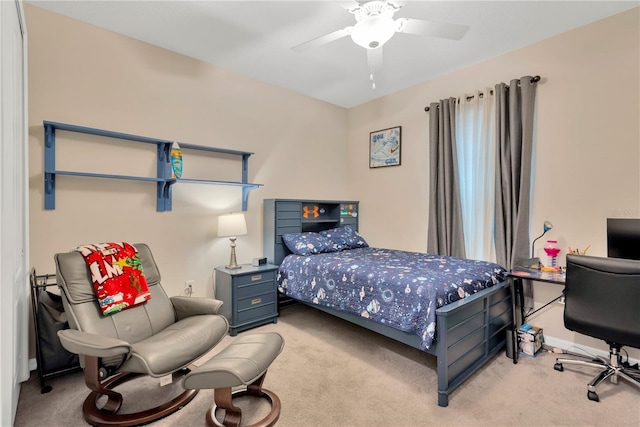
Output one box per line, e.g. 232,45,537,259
264,201,513,407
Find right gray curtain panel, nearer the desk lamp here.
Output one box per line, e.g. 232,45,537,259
495,76,537,308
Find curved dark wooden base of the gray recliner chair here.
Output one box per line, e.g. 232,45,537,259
82,357,199,427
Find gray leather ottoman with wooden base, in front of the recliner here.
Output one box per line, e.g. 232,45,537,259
184,332,284,427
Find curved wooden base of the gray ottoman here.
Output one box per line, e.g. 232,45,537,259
207,372,281,427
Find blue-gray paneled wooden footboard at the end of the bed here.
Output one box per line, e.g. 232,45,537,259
435,281,513,406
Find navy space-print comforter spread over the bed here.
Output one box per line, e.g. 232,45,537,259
277,247,506,350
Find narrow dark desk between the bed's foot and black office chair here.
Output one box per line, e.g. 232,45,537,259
507,267,565,364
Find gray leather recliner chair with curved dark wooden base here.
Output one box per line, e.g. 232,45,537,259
54,243,229,426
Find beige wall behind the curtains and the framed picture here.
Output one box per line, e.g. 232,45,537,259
349,8,640,357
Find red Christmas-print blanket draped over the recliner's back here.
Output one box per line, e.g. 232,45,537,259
75,242,151,316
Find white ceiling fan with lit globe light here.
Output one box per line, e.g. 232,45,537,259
292,0,469,90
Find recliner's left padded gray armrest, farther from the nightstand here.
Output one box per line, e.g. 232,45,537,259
58,329,131,357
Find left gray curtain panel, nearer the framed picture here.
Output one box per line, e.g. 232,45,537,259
427,98,465,258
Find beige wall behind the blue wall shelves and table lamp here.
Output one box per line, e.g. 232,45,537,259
26,0,348,310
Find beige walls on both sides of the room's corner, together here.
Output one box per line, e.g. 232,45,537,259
26,5,640,362
